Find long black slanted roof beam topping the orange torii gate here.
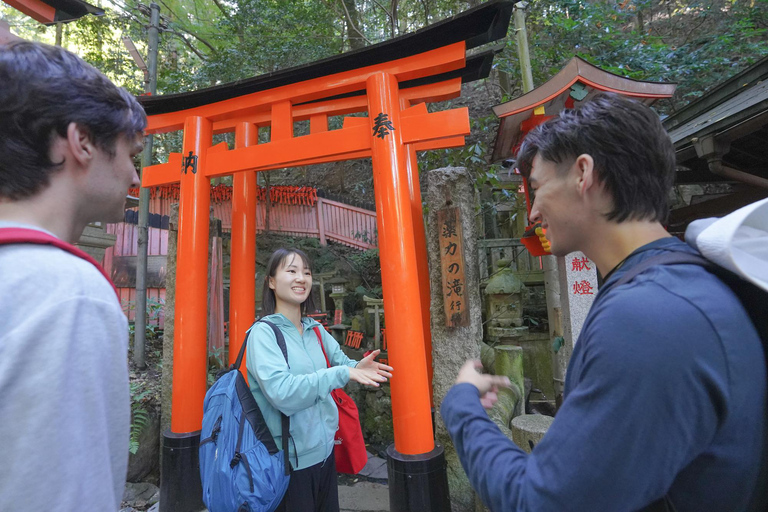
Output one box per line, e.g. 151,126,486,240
138,1,513,116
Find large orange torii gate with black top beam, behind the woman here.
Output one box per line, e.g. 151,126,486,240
141,2,512,510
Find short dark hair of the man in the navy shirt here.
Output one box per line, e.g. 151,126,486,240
517,94,675,223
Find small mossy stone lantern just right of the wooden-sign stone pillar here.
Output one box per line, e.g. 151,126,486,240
485,260,525,327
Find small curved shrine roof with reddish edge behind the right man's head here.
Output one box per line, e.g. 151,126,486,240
492,57,677,161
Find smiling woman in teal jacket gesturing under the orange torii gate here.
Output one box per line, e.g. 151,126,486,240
246,249,392,512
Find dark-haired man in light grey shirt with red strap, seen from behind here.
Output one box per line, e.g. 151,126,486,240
0,41,146,511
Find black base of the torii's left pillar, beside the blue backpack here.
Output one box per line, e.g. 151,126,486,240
160,430,205,512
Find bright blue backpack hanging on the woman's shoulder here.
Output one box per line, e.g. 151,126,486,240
200,320,291,512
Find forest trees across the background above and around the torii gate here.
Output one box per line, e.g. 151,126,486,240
0,0,768,203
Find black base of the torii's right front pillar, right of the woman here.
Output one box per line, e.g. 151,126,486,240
387,444,451,512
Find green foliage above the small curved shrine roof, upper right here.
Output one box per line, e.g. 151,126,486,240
497,0,768,110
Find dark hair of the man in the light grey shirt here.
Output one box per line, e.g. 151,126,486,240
0,41,147,200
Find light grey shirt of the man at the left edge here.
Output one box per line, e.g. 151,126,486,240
0,223,130,512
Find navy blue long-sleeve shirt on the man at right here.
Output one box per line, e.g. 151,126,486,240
441,238,766,512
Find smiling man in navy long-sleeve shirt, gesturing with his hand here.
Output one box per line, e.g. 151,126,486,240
441,95,766,512
